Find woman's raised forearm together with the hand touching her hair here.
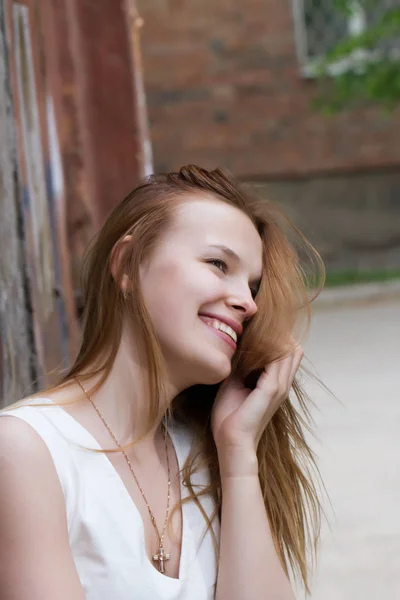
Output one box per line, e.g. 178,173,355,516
211,345,304,600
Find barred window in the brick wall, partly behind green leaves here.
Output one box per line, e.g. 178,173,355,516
293,0,400,75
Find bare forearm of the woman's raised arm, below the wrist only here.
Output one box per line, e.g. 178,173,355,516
216,456,294,600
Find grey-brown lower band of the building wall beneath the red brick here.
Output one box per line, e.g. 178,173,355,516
258,169,400,271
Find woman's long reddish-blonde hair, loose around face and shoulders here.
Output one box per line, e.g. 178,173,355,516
52,165,324,591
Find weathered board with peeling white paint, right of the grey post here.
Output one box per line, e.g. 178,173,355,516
0,0,75,404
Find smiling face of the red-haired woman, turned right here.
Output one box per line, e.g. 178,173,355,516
141,196,262,391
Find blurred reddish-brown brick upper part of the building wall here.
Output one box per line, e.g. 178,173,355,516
138,0,400,179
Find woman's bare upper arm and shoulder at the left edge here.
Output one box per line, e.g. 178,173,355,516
0,416,85,600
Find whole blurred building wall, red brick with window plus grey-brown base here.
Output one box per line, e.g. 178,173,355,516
138,0,400,268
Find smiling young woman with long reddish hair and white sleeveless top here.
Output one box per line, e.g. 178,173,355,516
0,166,323,600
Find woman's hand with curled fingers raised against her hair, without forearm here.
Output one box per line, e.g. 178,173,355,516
211,344,304,476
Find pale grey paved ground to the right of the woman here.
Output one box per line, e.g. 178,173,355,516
298,299,400,600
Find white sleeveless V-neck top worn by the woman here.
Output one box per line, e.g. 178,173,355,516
1,398,220,600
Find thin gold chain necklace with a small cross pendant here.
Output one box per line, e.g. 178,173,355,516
75,377,171,573
